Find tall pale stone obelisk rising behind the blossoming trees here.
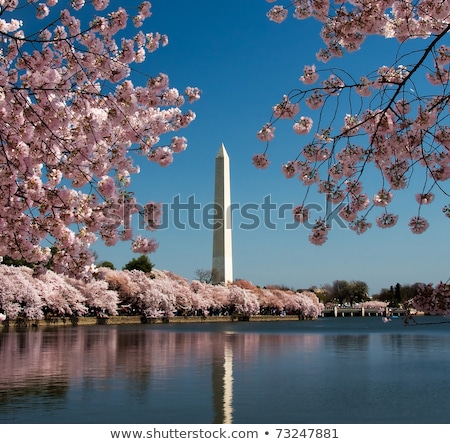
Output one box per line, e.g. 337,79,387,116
212,144,233,285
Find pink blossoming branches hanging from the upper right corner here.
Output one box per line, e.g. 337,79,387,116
253,0,450,245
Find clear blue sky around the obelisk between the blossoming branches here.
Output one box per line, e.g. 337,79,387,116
94,0,450,294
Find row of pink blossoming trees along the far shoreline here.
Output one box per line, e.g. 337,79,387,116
0,265,323,320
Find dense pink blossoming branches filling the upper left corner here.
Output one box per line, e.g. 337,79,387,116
0,0,199,277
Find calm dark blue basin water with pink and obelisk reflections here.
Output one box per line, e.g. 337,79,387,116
0,317,450,424
